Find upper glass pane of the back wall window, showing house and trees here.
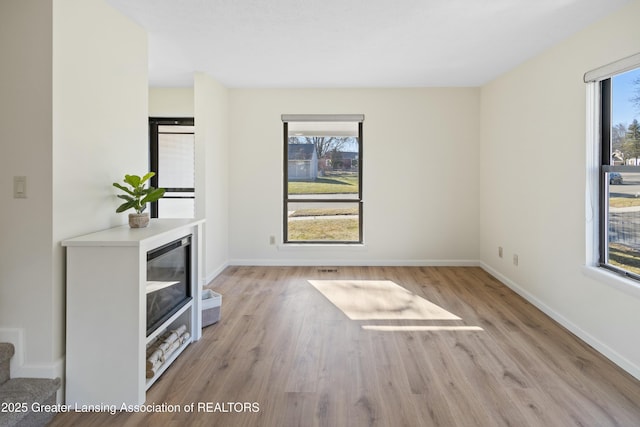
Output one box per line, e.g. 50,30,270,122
287,122,360,199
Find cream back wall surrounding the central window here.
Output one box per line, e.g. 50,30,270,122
229,88,480,265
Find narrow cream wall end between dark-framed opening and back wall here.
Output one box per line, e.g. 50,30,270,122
193,73,230,282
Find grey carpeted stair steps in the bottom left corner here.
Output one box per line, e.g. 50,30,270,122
0,343,60,427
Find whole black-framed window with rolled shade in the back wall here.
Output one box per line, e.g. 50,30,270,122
282,115,364,243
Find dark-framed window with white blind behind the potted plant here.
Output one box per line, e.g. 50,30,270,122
149,118,195,218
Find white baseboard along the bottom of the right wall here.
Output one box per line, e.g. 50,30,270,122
480,262,640,380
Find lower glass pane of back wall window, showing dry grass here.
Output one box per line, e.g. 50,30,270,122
287,202,360,242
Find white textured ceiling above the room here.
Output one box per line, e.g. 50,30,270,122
108,0,629,88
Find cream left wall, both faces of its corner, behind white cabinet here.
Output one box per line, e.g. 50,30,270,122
0,0,148,382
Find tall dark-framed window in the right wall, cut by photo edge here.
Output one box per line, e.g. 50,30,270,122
594,58,640,280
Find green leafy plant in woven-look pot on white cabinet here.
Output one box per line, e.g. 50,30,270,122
113,172,165,228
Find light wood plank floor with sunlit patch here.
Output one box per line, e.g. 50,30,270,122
52,267,640,427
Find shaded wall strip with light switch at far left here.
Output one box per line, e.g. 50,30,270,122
0,0,54,373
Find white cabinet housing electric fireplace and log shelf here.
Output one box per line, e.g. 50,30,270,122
62,219,204,407
